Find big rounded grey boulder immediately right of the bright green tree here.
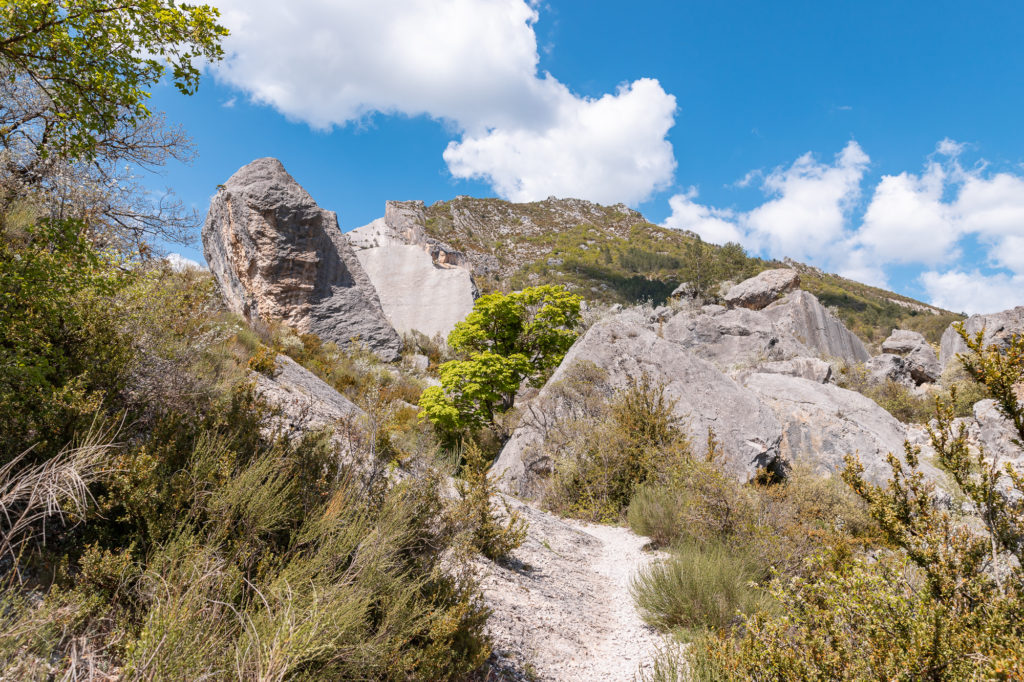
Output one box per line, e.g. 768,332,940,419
494,310,781,496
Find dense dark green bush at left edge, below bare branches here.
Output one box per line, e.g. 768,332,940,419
0,221,132,465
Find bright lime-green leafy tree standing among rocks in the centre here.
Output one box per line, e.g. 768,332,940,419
420,285,582,440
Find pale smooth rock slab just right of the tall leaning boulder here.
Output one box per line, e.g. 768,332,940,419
346,202,476,338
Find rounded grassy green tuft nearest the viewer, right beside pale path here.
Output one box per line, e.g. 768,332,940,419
630,544,765,631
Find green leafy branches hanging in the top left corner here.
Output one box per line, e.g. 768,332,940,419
0,0,227,159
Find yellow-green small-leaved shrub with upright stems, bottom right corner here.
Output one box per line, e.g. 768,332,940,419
690,327,1024,680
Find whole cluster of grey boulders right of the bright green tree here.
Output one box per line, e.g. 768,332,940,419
494,291,940,497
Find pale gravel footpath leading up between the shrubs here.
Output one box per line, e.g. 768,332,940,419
476,493,662,681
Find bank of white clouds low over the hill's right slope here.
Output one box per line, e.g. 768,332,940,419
665,139,1024,312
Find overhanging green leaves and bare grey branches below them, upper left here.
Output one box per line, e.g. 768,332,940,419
0,0,226,252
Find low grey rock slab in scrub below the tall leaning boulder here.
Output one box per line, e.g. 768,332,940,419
252,355,365,461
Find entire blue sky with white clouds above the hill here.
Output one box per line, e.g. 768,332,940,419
147,0,1024,312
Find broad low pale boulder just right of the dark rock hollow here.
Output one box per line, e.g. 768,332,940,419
743,373,940,483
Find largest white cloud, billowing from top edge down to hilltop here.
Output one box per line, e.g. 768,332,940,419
206,0,676,204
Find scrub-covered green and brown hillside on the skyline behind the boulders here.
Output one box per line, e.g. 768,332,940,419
426,197,963,344
